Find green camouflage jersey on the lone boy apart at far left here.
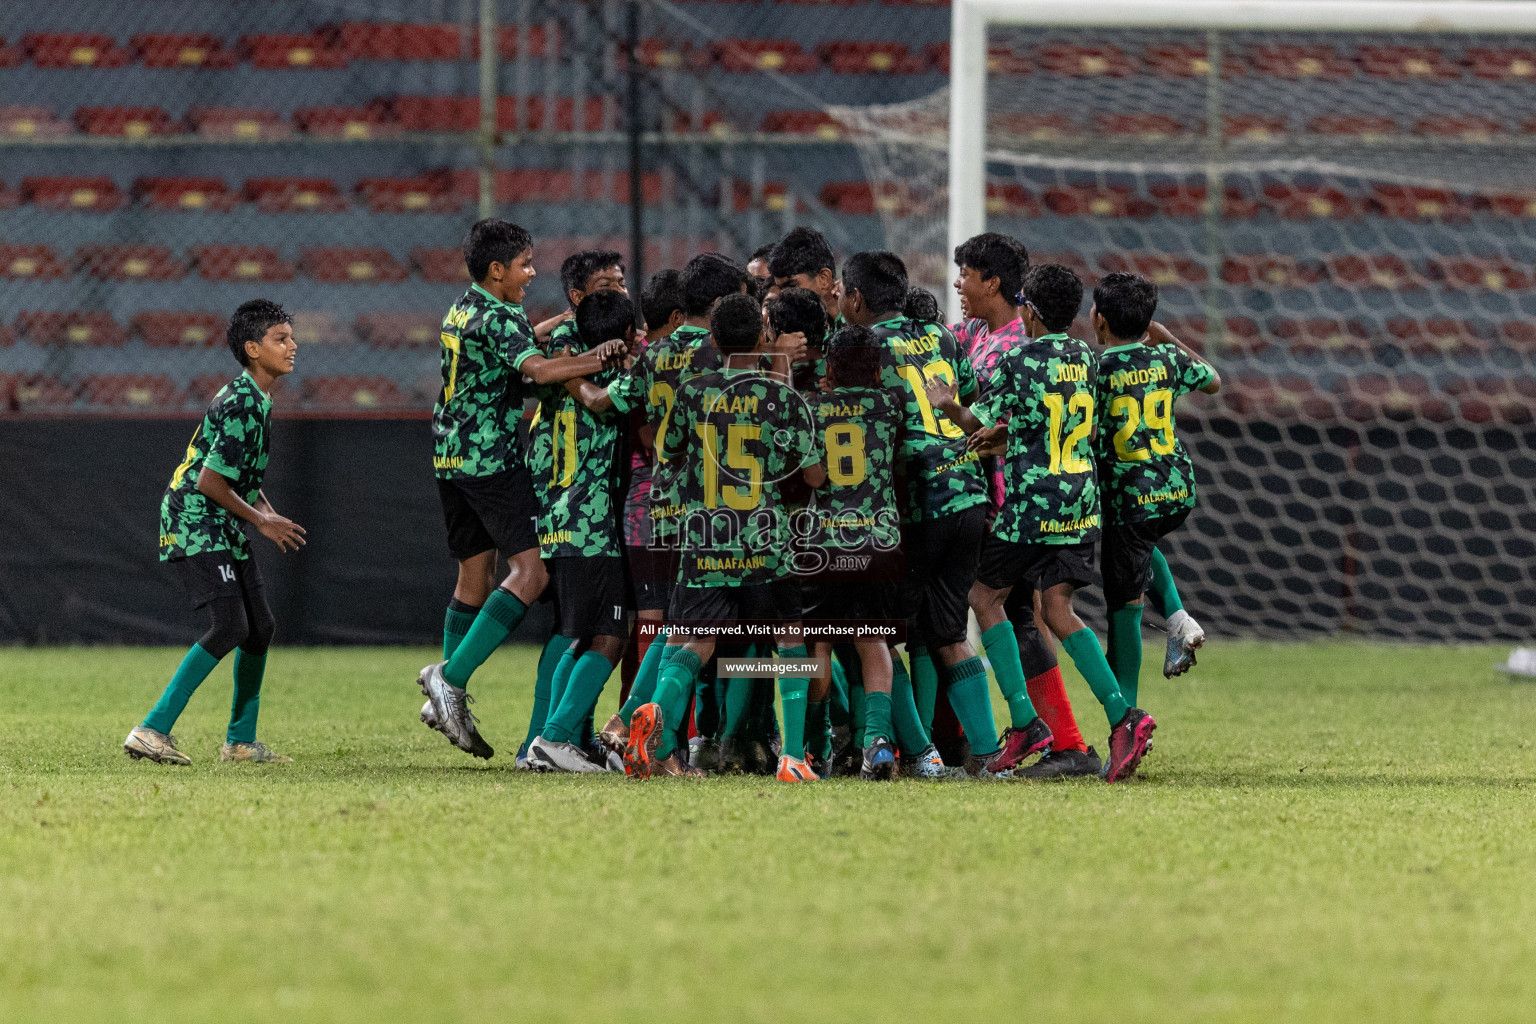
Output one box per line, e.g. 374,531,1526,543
160,373,272,562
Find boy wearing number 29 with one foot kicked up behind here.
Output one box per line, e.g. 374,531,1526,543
1089,273,1221,705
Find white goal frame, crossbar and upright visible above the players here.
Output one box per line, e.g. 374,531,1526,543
949,0,1536,321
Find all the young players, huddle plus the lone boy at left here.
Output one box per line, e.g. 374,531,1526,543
124,220,1218,783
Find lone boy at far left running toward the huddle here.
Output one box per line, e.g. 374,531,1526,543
123,299,304,765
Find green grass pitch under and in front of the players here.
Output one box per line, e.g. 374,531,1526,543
0,640,1536,1024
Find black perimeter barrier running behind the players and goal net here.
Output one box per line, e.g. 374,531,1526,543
0,416,1536,645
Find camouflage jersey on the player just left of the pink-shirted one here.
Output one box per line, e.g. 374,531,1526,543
872,316,986,522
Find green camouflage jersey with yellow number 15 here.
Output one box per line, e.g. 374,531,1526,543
656,368,816,586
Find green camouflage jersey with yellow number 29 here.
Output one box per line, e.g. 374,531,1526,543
1097,342,1212,522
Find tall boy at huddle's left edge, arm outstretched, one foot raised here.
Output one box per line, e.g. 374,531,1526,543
418,218,625,758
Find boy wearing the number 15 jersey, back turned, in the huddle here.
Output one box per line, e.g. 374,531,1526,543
625,295,816,781
